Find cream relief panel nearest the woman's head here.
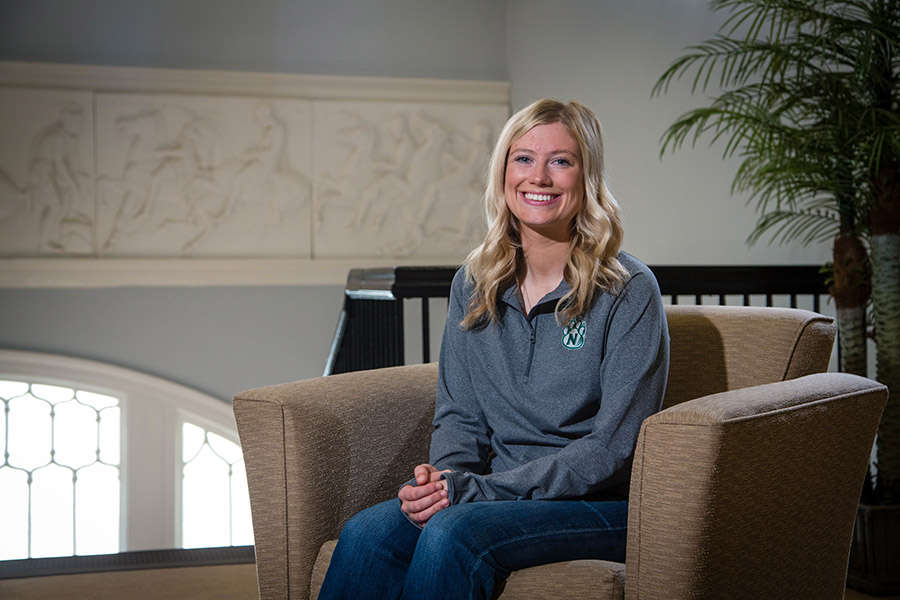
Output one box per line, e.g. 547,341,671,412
313,102,506,258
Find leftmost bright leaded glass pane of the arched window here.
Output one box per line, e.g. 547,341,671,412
0,380,121,560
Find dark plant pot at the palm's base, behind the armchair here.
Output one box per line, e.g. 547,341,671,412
847,504,900,596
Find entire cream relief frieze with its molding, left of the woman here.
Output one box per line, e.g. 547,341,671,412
0,62,509,268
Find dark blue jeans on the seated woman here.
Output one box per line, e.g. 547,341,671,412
319,499,628,600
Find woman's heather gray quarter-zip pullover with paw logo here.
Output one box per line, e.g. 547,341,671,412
430,253,669,504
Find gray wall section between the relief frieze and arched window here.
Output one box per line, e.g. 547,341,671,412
0,286,343,399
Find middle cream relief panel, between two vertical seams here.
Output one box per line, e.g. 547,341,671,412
96,94,312,257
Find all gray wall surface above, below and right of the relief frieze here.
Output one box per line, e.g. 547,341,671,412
0,0,828,398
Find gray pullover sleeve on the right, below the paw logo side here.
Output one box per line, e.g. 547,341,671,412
442,273,669,504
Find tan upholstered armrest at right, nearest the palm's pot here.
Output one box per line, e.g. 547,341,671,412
626,373,887,600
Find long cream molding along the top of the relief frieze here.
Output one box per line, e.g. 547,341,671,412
0,61,510,104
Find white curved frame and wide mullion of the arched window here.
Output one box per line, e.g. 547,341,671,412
0,349,240,552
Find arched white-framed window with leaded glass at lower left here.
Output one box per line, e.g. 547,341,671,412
0,350,253,559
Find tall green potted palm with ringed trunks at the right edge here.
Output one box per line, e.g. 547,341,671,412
654,0,900,593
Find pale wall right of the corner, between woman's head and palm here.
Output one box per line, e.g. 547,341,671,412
507,0,830,265
